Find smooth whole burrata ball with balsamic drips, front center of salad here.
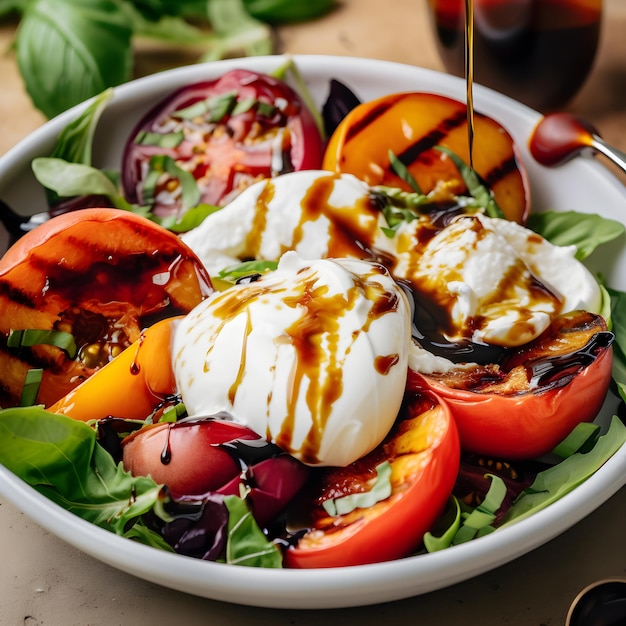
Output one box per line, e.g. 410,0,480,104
173,252,411,466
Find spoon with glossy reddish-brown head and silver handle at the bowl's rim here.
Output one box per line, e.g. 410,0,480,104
529,113,626,172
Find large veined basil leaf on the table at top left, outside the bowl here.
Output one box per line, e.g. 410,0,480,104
16,0,132,117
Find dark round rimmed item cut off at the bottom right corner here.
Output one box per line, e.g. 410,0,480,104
565,578,626,626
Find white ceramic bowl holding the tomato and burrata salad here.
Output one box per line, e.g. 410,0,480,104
0,56,626,609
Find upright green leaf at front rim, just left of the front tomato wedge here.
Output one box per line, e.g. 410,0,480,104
224,496,282,568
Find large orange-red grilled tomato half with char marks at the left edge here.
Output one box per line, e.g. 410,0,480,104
0,208,213,407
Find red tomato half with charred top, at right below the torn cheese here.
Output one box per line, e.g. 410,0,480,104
407,312,612,460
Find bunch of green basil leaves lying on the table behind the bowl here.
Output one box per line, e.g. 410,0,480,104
0,0,336,117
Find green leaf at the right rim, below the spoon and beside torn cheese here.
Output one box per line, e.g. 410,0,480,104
528,211,626,261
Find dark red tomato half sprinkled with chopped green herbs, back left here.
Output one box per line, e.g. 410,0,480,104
122,69,323,216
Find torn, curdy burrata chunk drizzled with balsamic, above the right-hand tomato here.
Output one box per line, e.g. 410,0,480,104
394,214,601,346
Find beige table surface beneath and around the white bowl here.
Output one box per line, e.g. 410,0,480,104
0,0,626,626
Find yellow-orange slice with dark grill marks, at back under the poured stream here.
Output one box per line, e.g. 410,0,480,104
322,92,530,223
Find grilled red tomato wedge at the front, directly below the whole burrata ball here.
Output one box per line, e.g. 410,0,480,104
285,394,460,568
